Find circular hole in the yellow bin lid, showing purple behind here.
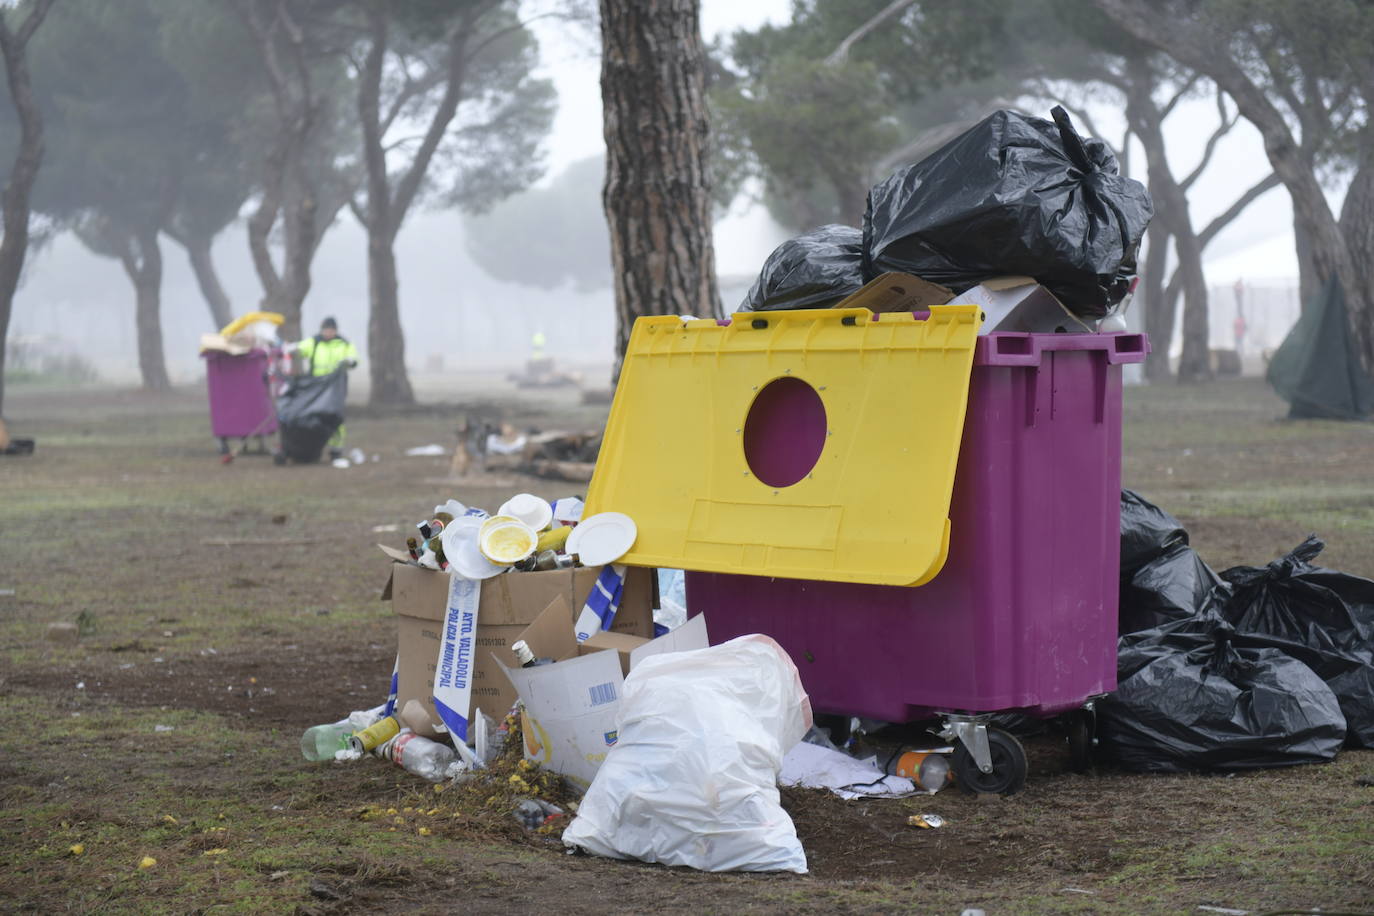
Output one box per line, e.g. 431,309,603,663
743,376,827,488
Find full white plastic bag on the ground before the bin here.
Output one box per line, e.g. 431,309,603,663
563,636,811,873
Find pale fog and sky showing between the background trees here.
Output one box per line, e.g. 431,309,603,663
11,0,1313,383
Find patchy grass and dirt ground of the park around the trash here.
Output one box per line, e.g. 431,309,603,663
0,380,1374,913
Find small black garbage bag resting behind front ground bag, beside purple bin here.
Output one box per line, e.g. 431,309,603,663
1117,544,1230,634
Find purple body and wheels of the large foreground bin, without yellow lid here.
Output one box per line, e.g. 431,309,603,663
687,334,1149,792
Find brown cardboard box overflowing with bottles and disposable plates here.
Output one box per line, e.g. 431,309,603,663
382,548,657,735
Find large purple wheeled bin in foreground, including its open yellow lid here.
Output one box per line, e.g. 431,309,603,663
587,306,1149,792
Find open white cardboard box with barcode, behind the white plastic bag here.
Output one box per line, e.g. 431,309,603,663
496,595,708,788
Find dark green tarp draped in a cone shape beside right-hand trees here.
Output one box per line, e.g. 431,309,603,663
1265,277,1374,420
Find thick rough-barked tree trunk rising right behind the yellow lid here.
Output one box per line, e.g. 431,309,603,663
600,0,721,379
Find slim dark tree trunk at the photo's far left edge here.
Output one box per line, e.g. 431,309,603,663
0,0,52,416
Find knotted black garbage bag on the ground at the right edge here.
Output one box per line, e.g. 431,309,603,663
1221,536,1374,747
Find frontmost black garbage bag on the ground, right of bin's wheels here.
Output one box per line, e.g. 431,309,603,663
1096,614,1345,773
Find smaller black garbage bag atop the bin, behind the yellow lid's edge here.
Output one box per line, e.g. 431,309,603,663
739,224,863,312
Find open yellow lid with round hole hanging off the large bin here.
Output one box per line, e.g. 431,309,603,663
584,305,981,585
